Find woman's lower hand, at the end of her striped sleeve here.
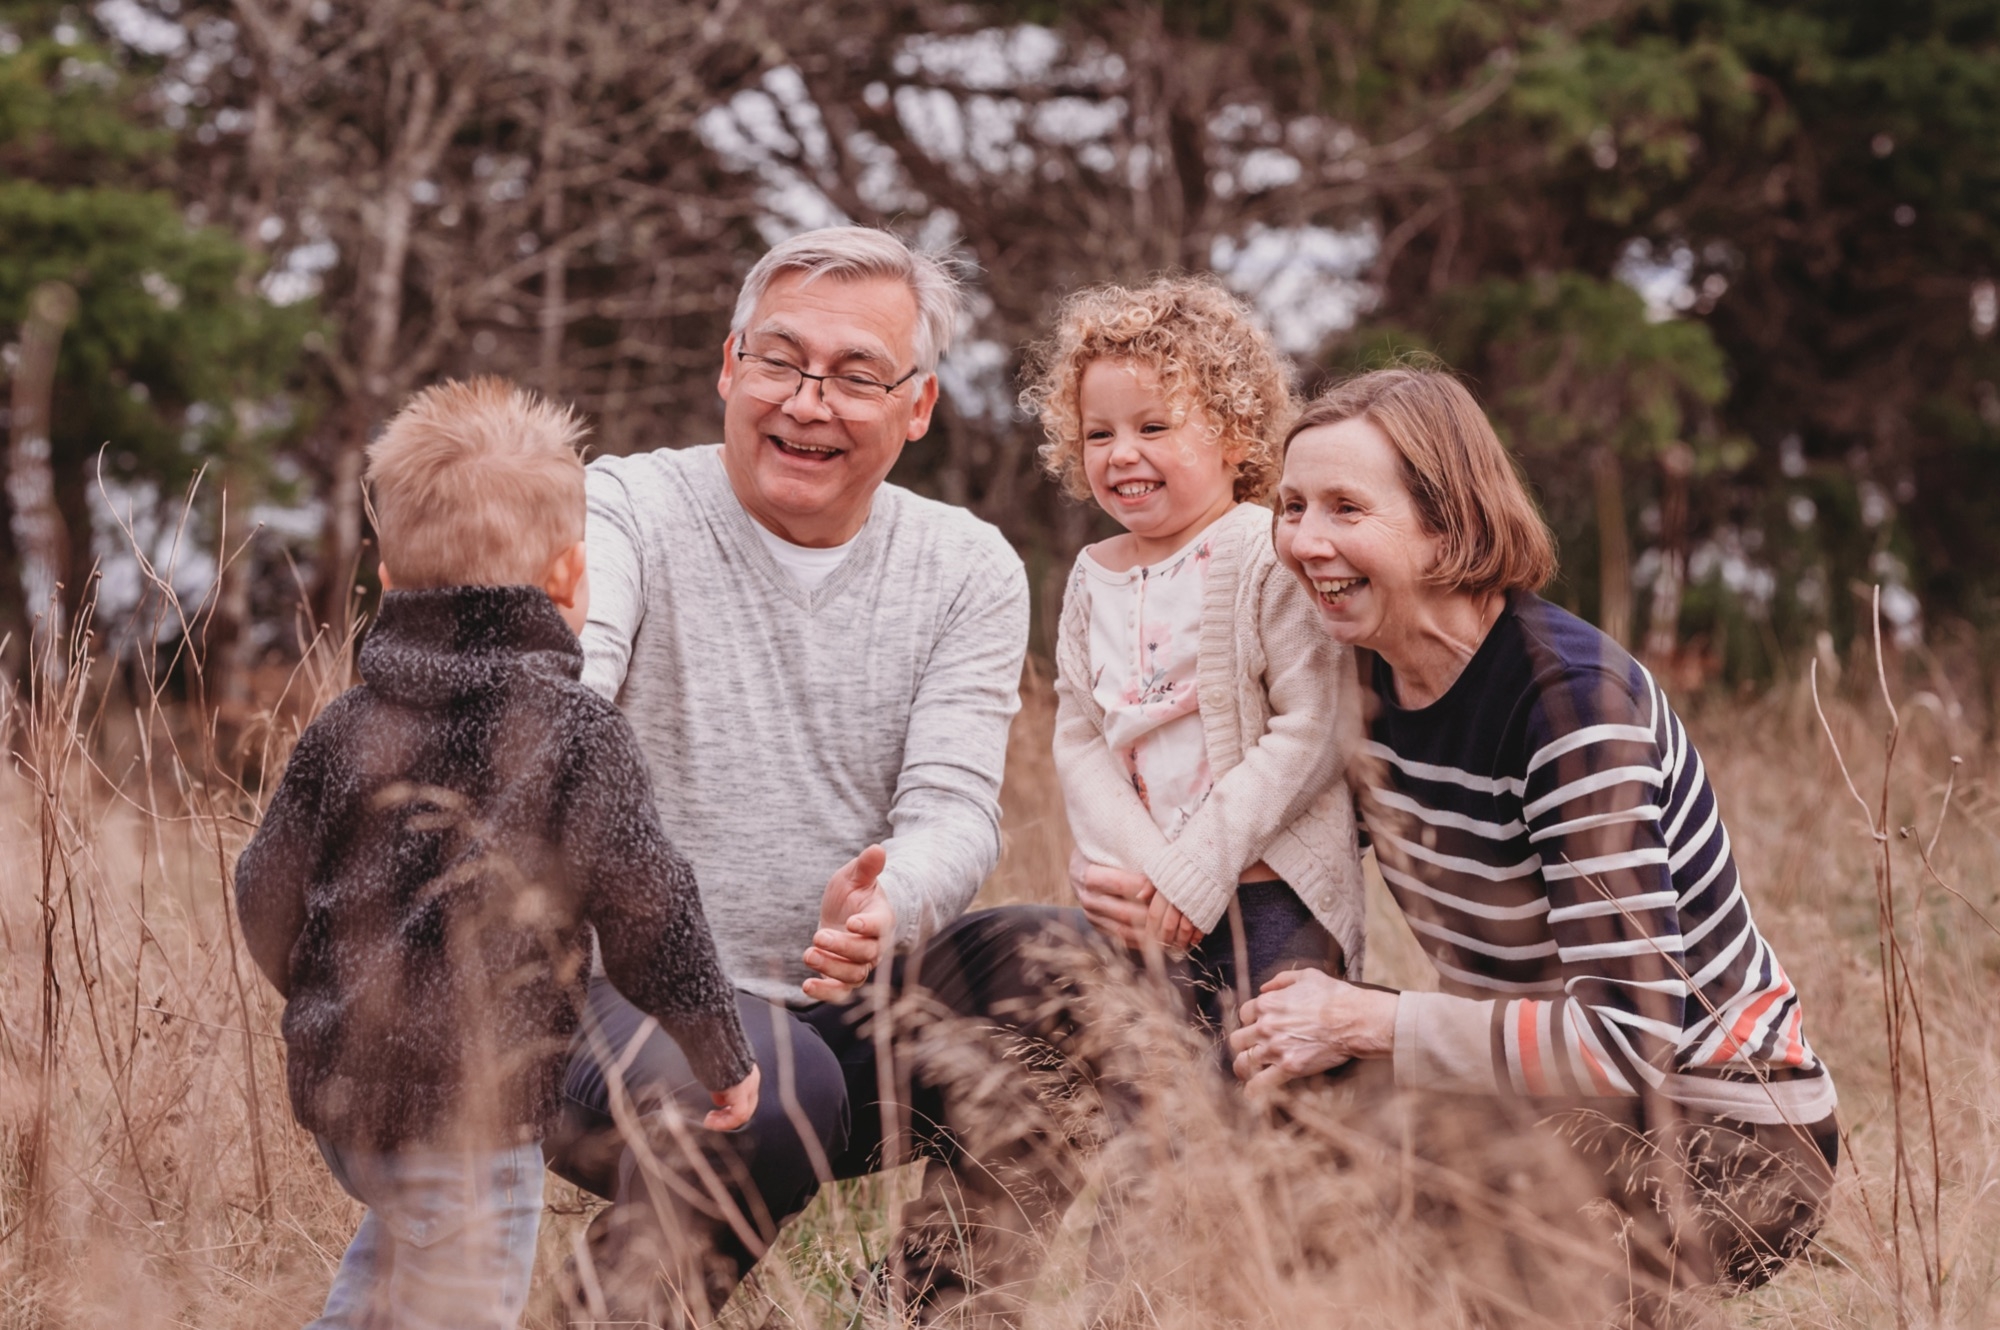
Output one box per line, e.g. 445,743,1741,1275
1230,970,1396,1090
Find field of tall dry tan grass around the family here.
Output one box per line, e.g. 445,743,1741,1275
0,632,2000,1330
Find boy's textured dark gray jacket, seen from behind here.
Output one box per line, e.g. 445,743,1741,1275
236,586,752,1150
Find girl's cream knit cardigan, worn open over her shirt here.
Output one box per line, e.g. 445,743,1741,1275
1056,504,1364,978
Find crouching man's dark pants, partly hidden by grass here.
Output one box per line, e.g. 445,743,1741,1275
546,906,1092,1318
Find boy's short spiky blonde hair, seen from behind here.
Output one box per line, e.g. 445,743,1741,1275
368,378,588,590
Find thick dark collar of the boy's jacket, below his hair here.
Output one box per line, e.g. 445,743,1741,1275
358,586,584,706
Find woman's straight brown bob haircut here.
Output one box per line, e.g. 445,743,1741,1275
1284,366,1556,596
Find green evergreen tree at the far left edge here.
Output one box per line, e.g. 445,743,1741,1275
0,4,310,676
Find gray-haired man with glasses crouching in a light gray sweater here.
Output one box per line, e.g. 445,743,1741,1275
552,228,1080,1314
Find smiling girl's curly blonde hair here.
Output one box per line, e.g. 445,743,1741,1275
1020,276,1294,502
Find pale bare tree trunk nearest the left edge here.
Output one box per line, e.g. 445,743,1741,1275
6,282,76,680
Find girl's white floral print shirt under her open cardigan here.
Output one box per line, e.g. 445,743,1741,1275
1070,532,1214,840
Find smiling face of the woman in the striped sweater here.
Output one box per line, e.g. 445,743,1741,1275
1274,416,1450,650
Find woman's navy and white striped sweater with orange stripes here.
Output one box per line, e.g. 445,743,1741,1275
1350,594,1834,1124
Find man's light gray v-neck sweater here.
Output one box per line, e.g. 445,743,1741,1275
584,444,1028,1002
